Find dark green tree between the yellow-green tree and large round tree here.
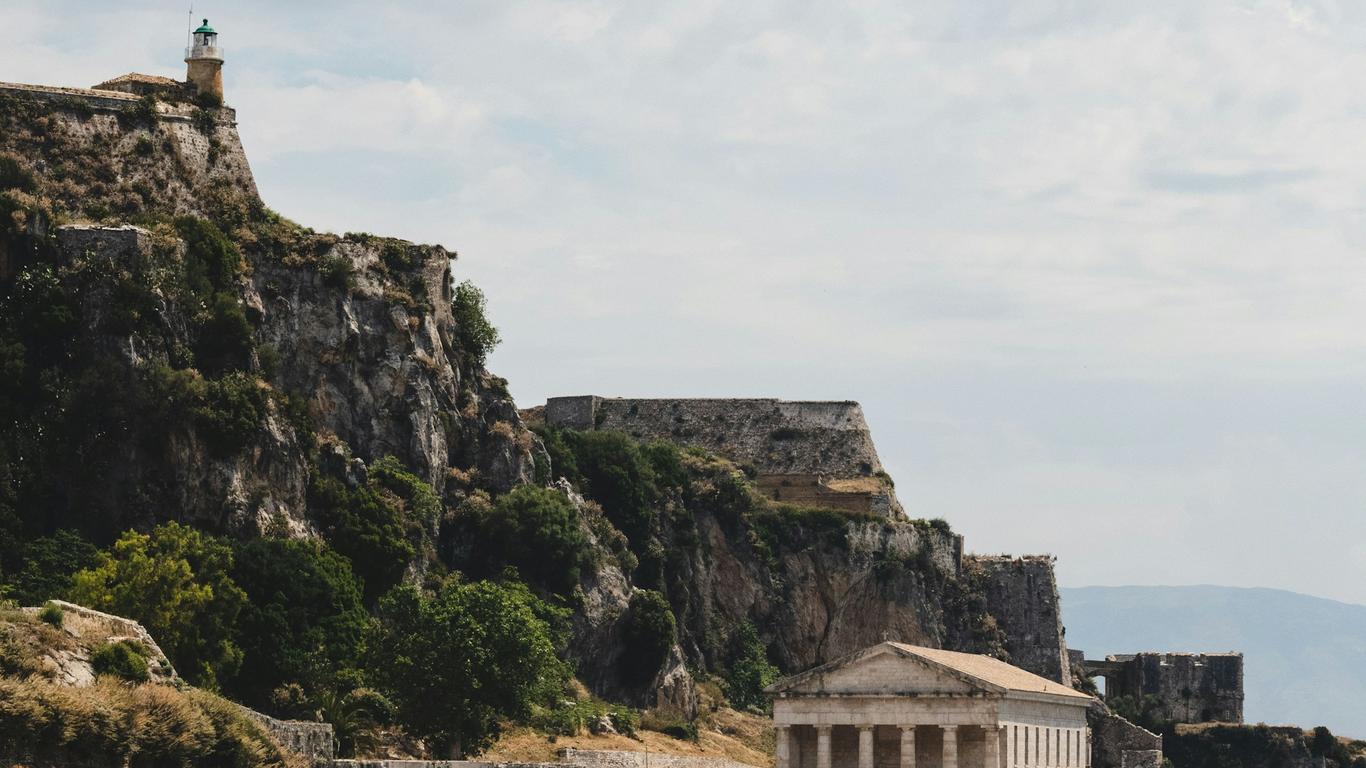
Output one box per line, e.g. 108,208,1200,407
224,538,369,707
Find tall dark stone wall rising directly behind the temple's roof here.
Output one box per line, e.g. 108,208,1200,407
968,555,1072,686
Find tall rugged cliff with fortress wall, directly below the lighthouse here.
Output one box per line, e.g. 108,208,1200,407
0,86,535,540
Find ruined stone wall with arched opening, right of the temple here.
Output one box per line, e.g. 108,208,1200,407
1105,653,1243,723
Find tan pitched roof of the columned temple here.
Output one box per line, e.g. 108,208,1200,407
765,641,1091,702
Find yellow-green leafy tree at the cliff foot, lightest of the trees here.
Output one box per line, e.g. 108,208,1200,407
71,522,246,689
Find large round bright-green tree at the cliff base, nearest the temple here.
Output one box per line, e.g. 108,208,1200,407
366,579,568,756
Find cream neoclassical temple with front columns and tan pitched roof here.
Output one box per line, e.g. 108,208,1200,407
768,642,1091,768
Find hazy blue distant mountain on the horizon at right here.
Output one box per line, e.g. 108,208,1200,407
1061,586,1366,738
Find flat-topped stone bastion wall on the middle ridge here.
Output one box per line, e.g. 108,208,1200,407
544,395,903,518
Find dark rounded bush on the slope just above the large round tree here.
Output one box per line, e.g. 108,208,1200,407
466,485,589,594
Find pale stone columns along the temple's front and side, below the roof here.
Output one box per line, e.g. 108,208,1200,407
776,724,1091,768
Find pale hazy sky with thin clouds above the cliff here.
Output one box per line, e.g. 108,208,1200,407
0,0,1366,603
